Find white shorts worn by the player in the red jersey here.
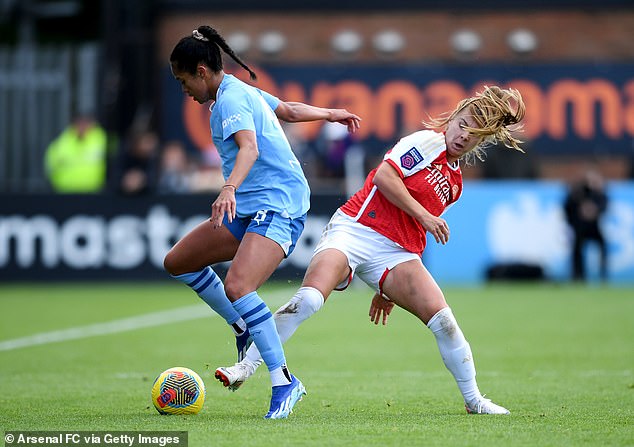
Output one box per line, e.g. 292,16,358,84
313,210,422,296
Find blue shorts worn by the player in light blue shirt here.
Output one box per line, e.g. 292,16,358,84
222,210,306,258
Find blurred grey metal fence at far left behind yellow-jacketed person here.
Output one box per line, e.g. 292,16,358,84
0,44,99,193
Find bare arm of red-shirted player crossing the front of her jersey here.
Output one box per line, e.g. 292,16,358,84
373,162,449,245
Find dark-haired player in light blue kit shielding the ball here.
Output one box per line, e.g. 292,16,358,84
164,26,360,419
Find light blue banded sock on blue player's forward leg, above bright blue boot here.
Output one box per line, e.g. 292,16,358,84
233,292,286,371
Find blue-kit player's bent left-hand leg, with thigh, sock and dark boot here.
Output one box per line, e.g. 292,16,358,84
163,220,250,361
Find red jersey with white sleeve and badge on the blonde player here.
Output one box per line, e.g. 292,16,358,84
340,130,462,255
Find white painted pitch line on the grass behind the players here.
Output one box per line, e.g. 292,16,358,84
0,293,288,352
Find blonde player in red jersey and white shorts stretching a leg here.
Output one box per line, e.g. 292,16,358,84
216,86,525,414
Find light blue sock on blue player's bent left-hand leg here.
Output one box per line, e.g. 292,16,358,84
173,267,240,324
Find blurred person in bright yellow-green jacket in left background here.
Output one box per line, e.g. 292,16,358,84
45,115,108,193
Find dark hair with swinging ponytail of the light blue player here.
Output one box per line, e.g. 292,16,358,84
170,25,257,80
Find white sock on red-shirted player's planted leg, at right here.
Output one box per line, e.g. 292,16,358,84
427,307,480,402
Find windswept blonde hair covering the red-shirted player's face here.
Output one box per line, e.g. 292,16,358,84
424,86,526,164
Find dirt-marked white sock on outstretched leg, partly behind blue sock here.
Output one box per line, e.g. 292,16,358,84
242,287,324,371
